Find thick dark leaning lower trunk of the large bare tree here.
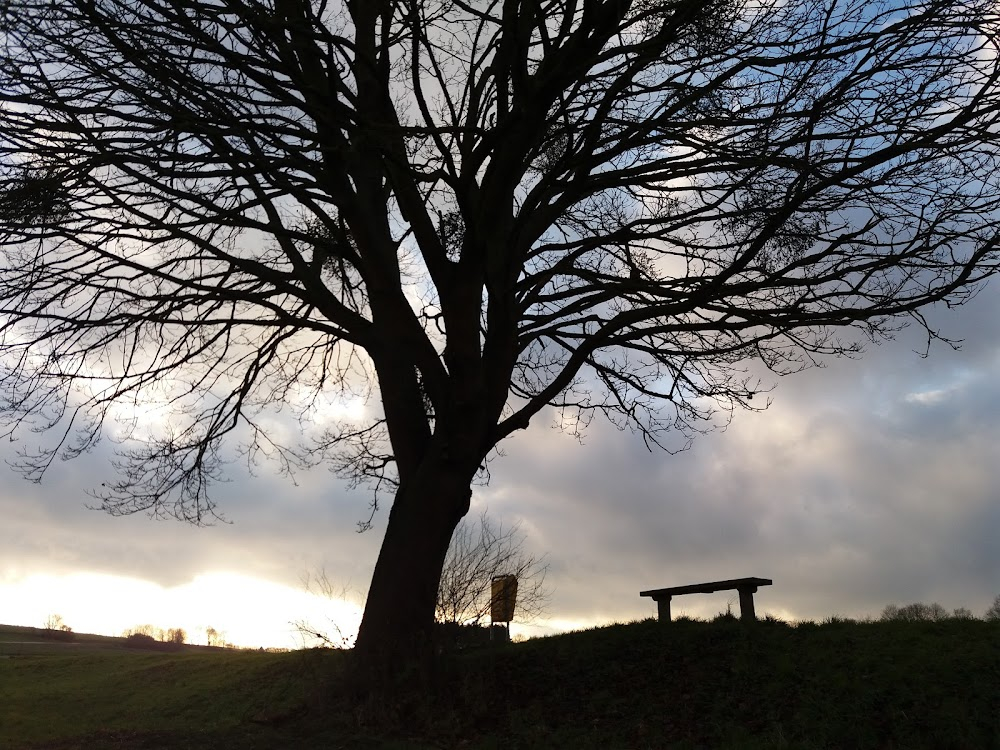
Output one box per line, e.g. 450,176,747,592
355,460,473,682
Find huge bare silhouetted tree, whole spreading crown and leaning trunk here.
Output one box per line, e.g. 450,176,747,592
0,0,1000,668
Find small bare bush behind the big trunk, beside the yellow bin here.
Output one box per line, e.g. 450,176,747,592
435,511,551,625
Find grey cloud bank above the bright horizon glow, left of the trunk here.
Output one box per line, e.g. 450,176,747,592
0,434,379,587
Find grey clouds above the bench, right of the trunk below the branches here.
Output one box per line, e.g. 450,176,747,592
479,290,1000,619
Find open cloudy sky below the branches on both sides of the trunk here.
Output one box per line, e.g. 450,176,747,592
0,284,1000,648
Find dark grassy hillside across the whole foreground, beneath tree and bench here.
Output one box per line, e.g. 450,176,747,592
0,620,1000,750
